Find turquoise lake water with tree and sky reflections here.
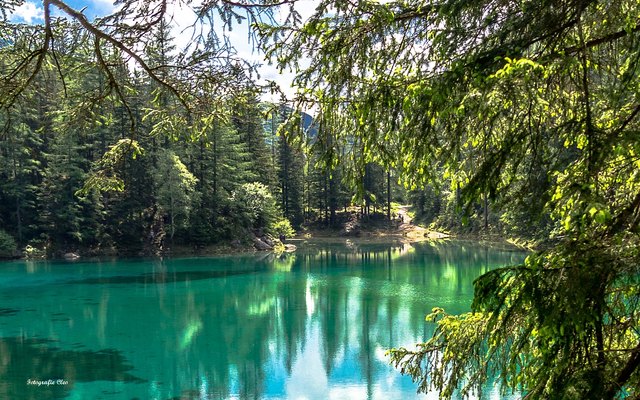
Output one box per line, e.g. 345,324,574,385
0,240,525,400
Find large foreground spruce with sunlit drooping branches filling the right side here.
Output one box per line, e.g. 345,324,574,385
262,0,640,399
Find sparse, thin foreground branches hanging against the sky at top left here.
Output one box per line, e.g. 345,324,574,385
0,0,295,130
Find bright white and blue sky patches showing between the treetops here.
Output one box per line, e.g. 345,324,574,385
6,0,317,102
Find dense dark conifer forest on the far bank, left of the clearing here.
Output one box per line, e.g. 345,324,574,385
0,14,387,257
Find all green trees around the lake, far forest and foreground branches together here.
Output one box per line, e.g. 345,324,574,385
0,0,640,399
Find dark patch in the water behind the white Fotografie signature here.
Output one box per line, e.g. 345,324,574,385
0,337,145,400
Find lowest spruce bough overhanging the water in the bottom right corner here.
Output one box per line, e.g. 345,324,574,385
391,236,640,399
